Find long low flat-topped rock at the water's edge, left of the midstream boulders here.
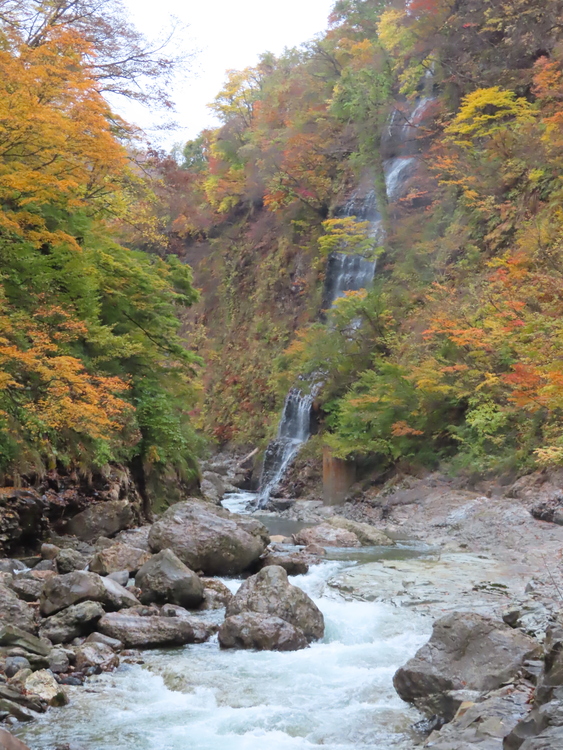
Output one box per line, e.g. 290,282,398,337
98,612,205,648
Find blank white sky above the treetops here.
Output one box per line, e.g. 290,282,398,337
121,0,334,147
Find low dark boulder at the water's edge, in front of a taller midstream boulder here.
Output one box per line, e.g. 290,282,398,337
219,612,309,651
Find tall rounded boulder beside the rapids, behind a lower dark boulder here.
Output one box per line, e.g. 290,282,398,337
226,565,324,641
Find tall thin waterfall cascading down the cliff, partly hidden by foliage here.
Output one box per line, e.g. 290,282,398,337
258,96,433,507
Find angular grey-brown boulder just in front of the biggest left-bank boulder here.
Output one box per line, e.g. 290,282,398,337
135,549,203,609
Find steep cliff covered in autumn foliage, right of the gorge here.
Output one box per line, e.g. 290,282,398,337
165,0,563,482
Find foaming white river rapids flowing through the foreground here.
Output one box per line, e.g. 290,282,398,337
19,561,429,750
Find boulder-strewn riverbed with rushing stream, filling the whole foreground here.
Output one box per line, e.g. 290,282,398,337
0,466,563,750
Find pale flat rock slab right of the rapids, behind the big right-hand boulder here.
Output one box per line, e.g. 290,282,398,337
328,553,526,614
